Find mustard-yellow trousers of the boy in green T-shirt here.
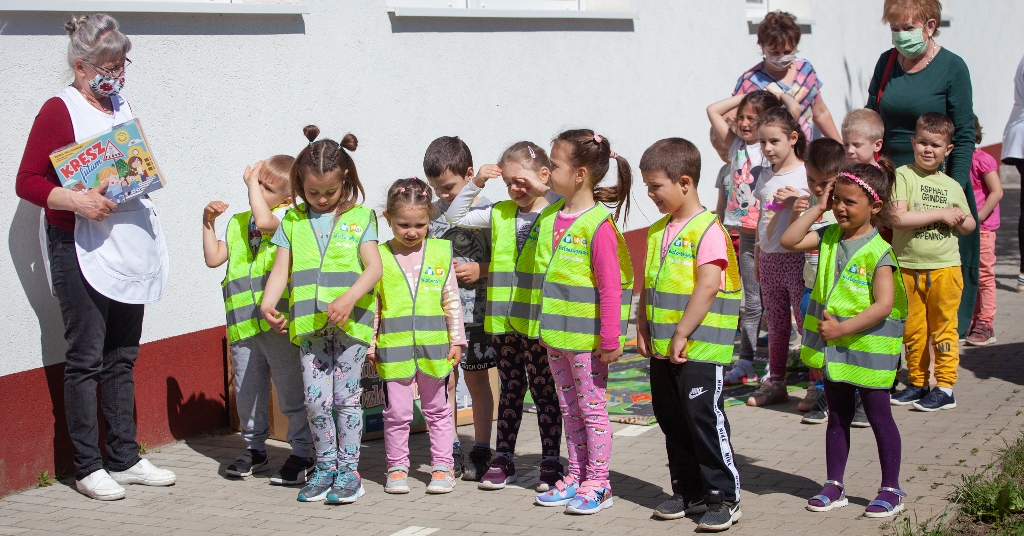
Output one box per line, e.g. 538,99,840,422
901,266,964,387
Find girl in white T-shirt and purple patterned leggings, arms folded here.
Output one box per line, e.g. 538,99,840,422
746,108,810,406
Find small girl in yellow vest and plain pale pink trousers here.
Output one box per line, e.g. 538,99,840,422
368,178,466,493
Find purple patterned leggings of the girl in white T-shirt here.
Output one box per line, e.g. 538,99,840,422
758,252,804,381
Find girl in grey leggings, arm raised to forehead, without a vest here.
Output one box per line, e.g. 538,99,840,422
708,91,782,385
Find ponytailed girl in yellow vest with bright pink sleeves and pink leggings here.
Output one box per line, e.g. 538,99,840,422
513,129,633,513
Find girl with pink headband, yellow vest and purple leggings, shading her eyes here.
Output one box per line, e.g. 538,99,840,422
780,161,907,518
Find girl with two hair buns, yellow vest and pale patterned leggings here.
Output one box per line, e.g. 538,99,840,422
260,125,382,504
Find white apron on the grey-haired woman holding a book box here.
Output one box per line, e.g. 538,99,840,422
40,86,169,303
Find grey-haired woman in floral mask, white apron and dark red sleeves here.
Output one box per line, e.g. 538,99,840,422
16,14,175,500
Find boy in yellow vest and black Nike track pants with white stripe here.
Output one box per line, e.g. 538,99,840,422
637,137,740,532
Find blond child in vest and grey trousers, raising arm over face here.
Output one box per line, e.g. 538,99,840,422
203,155,313,485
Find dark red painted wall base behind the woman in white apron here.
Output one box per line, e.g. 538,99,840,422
0,327,227,496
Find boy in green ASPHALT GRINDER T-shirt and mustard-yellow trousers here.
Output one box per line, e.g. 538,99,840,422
892,113,976,411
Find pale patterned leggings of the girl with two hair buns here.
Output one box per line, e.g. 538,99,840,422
299,328,367,470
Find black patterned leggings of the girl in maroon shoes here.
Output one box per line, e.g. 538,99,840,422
490,333,562,457
